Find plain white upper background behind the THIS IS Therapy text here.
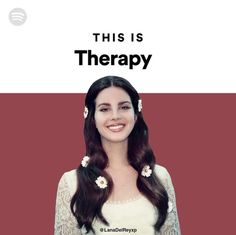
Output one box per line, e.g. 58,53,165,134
0,0,236,93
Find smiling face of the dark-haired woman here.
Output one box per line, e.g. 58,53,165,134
94,87,136,144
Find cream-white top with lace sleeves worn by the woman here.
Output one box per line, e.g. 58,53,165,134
54,165,181,235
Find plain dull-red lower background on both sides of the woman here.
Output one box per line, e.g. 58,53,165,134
0,94,236,235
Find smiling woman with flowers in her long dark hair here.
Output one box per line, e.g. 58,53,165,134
55,76,180,235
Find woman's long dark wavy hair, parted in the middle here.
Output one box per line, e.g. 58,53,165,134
70,76,168,232
